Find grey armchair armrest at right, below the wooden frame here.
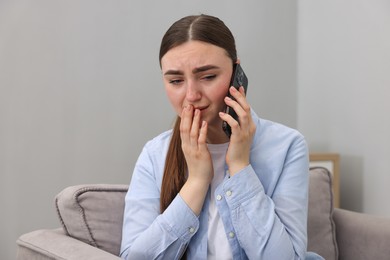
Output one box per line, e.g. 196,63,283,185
333,208,390,260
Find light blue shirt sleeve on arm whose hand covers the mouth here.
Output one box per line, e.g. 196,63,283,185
120,145,199,260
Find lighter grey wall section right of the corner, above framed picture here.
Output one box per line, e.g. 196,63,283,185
297,0,390,217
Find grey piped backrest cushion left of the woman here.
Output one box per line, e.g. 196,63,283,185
55,184,128,255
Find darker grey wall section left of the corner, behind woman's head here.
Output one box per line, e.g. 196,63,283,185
0,0,298,259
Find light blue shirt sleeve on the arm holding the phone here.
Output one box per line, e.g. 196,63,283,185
223,137,309,259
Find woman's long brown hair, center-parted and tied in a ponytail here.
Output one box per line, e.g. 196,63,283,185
159,14,237,212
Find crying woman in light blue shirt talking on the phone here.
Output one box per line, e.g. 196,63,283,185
121,15,322,260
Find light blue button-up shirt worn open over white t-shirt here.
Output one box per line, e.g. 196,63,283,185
121,112,309,260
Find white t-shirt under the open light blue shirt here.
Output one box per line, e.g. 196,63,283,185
207,143,233,260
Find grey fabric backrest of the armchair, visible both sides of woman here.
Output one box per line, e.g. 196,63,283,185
56,168,337,260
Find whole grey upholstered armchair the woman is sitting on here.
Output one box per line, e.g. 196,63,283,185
17,168,390,260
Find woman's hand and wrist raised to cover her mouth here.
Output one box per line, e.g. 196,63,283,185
180,105,214,215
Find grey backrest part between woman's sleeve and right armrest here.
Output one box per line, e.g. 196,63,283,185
307,167,338,260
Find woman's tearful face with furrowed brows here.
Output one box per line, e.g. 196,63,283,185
161,41,233,134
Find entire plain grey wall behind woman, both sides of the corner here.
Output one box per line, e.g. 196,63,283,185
0,0,390,259
